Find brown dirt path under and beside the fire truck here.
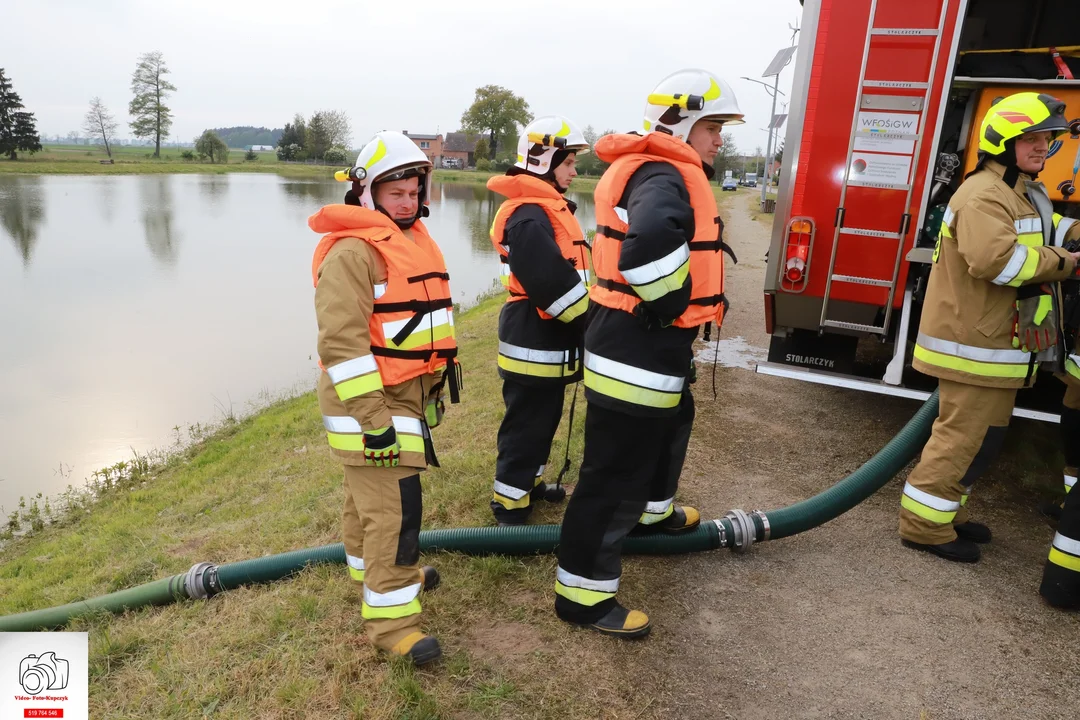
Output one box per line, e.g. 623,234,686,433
626,193,1080,720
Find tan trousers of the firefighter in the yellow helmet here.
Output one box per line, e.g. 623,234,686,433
900,380,1016,545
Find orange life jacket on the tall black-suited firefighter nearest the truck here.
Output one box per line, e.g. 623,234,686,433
589,133,726,327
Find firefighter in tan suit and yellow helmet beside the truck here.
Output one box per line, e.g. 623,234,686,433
900,93,1080,574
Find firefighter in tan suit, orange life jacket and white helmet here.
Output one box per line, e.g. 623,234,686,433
308,132,458,665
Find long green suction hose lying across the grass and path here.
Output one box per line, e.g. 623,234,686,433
0,392,937,633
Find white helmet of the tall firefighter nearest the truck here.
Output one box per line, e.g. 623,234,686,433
645,70,743,140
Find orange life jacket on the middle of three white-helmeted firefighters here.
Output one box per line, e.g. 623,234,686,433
487,175,590,320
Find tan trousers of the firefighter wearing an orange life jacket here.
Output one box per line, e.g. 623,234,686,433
341,465,423,650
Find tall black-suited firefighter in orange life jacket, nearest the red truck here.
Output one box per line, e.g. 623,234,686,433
555,70,743,638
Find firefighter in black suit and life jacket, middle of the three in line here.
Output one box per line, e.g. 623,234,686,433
487,116,589,526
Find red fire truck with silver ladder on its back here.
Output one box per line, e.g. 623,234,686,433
757,0,1080,421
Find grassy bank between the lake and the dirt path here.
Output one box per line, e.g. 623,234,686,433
0,298,663,718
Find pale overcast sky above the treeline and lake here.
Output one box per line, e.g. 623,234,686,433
6,0,801,151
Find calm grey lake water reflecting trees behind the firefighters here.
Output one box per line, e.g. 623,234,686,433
0,174,594,512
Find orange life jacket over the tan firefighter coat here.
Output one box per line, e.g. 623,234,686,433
308,205,458,390
